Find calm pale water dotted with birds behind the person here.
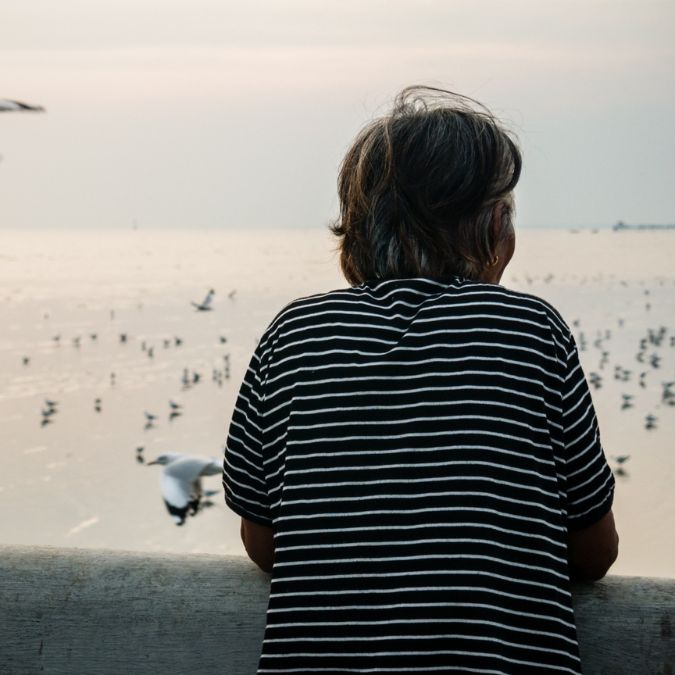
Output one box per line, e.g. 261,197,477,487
0,231,675,576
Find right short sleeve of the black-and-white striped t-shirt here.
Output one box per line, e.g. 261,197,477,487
562,338,614,530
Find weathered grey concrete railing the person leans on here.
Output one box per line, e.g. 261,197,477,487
0,546,675,675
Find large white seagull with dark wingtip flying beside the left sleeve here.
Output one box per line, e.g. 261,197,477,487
148,453,223,525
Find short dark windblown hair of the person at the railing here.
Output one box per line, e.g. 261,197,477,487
330,86,522,285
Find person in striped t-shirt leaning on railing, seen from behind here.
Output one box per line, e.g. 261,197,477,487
224,87,618,675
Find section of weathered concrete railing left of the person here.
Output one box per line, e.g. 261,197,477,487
0,547,269,675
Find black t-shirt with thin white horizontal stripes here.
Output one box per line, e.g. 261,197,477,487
224,278,614,675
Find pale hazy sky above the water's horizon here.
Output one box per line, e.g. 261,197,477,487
0,0,675,228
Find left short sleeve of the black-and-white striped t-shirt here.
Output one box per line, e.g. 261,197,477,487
223,350,272,527
